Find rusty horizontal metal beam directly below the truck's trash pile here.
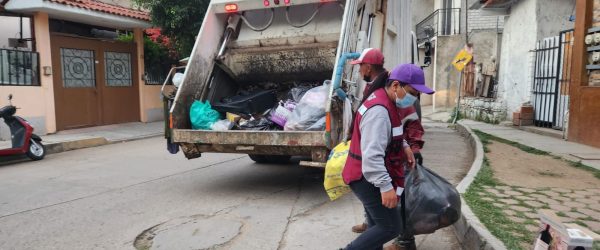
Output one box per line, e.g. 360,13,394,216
173,129,325,147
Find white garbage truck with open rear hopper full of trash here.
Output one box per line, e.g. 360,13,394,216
166,0,416,167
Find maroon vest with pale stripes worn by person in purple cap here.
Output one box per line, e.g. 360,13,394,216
342,88,406,189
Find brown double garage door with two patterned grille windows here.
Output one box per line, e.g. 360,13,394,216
51,35,140,130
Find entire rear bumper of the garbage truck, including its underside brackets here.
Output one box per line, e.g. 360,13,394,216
172,129,328,162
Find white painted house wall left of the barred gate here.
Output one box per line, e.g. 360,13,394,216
498,0,574,119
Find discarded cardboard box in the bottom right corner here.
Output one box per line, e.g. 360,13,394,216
533,210,600,250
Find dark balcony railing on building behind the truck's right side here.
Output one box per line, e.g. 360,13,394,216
416,8,461,43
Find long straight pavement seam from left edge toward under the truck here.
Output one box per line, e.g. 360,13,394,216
0,156,246,220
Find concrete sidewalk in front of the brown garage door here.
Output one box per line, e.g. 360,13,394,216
0,121,164,154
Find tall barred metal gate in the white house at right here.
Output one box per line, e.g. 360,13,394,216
532,30,573,130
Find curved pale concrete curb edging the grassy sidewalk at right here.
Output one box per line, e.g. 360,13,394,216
453,121,507,250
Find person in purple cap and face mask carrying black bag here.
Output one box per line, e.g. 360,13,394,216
342,64,433,249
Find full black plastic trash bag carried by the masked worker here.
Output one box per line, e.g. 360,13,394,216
404,166,461,235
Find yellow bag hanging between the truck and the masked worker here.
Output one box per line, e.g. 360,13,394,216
323,141,350,201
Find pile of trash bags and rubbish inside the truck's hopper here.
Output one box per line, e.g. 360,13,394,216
190,80,331,131
